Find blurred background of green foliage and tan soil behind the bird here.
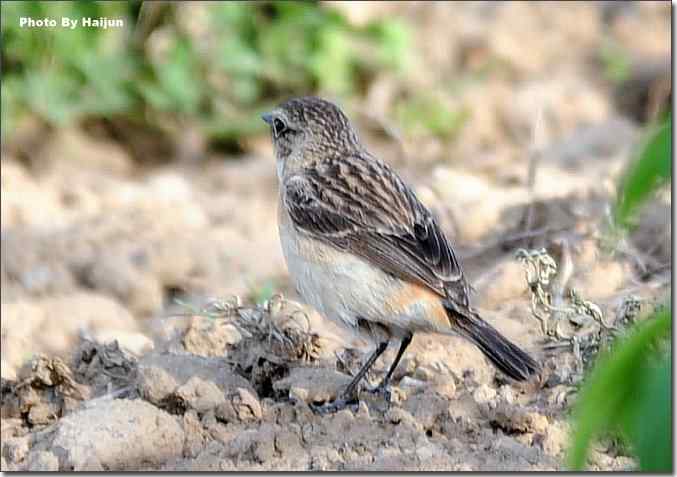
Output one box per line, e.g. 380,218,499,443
0,1,671,386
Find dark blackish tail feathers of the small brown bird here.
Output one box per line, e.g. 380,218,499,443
444,300,540,381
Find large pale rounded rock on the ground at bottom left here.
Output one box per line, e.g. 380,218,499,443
51,400,184,471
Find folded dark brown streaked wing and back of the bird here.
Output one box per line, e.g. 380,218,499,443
282,156,468,306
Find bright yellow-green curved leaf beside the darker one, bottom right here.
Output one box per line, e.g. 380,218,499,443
569,310,672,470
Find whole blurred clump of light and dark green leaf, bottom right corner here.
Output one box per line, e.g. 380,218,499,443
569,310,672,471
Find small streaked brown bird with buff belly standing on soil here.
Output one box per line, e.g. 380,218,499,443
262,96,540,414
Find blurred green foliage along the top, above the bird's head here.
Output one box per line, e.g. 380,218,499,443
1,1,409,139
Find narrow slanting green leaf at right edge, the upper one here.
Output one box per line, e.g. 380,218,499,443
615,115,672,226
